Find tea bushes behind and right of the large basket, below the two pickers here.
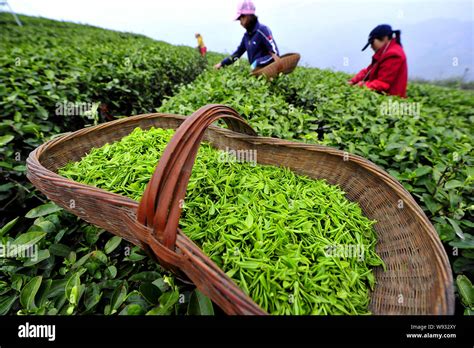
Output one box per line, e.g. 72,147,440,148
158,63,474,312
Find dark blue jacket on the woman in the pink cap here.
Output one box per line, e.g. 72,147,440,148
221,20,280,66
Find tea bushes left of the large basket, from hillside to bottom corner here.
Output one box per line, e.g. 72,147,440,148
0,13,211,315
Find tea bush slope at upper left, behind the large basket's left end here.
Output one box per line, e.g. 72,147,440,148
0,13,207,218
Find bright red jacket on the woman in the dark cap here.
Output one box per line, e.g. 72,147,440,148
351,40,408,98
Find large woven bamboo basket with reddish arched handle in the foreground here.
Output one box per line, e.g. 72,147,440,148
27,105,454,315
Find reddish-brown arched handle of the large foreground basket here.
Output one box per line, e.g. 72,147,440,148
137,104,257,252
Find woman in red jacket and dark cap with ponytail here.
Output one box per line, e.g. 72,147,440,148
349,24,408,98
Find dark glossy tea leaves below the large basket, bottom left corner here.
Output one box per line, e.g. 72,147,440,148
0,211,193,315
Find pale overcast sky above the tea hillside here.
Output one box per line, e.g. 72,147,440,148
4,0,474,78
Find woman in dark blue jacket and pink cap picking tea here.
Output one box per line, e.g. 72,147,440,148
214,0,279,69
